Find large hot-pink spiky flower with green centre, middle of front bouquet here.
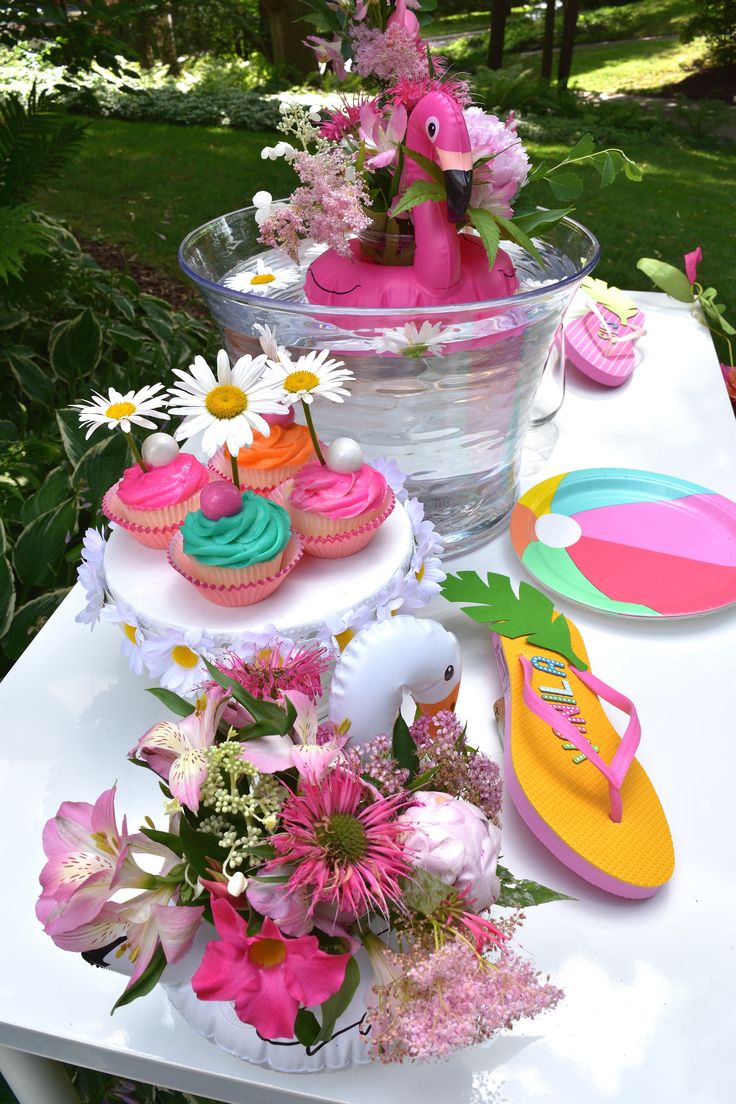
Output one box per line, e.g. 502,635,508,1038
265,766,410,916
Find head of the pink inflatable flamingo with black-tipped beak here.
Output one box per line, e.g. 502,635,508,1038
406,92,472,223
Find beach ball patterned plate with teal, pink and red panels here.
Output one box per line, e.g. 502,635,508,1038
511,468,736,617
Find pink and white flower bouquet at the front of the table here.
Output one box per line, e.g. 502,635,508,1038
36,641,562,1062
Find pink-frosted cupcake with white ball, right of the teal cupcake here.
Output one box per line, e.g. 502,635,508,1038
273,437,395,560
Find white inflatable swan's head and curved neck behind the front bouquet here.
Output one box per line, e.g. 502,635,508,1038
328,614,462,747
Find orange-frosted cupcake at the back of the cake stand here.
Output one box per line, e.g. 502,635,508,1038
209,408,316,495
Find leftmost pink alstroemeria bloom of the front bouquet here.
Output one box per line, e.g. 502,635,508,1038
36,786,149,937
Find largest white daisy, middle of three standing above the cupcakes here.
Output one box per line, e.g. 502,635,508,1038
169,349,284,456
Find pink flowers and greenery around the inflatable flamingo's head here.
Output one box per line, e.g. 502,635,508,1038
248,0,641,271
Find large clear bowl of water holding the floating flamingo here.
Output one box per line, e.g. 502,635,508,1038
179,208,599,554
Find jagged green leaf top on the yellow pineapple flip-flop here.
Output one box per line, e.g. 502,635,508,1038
441,571,588,670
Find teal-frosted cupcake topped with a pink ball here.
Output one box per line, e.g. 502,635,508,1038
169,480,302,606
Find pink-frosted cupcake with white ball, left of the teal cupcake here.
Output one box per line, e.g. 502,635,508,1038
103,433,210,549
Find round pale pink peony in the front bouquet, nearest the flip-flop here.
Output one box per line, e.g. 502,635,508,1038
398,790,501,912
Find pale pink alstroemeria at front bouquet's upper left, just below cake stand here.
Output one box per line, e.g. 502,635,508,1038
129,687,227,813
